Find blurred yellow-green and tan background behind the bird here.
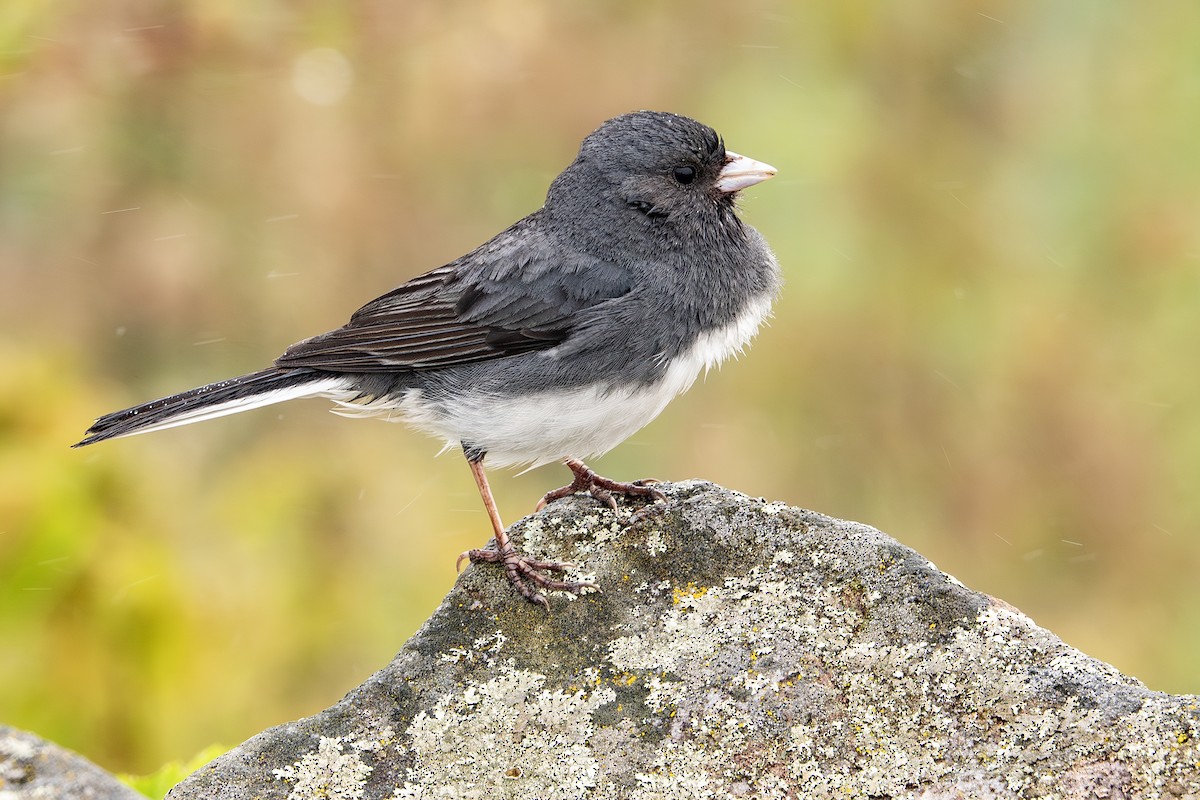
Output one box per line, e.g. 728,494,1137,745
0,0,1200,771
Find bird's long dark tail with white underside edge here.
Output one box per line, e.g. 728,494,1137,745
71,367,347,447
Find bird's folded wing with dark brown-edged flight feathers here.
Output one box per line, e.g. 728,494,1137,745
275,216,632,372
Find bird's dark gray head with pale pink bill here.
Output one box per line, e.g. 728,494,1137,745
546,112,775,250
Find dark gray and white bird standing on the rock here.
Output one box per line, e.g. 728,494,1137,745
72,110,781,608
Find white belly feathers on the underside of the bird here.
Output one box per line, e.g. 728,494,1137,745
335,297,770,467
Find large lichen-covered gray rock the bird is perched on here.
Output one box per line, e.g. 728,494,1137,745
169,483,1200,800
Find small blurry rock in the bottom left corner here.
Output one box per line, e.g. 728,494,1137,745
0,726,145,800
